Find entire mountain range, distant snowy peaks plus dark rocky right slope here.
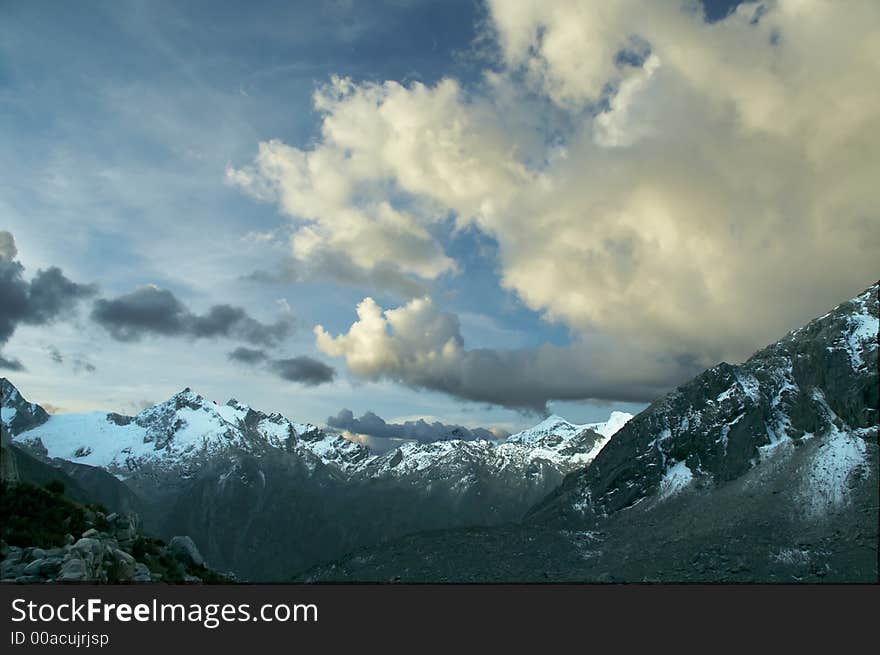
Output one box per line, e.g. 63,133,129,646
0,284,880,582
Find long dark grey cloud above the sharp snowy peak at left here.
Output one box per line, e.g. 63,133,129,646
91,285,292,346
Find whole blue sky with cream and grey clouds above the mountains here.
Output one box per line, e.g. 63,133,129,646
0,0,880,446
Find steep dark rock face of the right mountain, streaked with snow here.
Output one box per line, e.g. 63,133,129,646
534,284,880,520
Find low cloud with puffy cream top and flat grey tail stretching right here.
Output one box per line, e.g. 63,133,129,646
315,298,705,412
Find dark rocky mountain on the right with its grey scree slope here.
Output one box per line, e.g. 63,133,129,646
300,284,880,582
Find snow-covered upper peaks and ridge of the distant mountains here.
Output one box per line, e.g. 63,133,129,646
3,384,631,486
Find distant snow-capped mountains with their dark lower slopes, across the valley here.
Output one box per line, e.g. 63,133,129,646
4,381,628,580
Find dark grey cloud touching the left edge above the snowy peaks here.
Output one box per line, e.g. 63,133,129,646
0,231,97,370
